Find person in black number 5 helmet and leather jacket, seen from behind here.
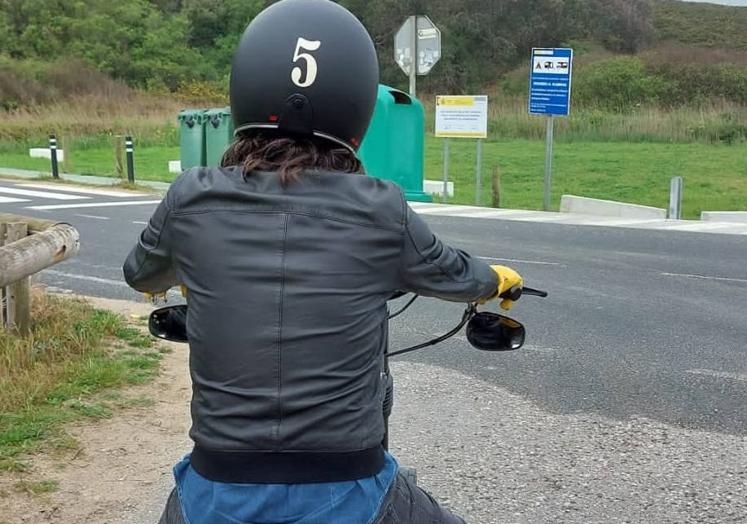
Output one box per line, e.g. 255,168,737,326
124,0,522,524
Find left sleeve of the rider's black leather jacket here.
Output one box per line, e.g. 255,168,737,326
122,194,179,293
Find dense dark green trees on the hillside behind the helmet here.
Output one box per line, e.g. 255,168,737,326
0,0,652,96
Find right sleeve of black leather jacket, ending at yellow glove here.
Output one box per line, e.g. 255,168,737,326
401,206,498,302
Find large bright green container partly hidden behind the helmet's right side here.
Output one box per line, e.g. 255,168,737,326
358,85,432,202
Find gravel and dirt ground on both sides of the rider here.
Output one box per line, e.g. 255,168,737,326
0,299,747,524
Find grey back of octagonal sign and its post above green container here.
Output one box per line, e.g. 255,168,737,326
394,15,441,97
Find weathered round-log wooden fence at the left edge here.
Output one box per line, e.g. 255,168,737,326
0,213,80,333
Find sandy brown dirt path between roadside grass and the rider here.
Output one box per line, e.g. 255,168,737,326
0,299,191,524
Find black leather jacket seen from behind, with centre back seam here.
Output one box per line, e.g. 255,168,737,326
124,168,496,483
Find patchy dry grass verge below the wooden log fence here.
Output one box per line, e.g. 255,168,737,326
0,293,161,472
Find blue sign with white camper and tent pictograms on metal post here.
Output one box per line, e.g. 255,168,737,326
529,48,573,211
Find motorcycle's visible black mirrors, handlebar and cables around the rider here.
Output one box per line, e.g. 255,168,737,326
148,287,548,484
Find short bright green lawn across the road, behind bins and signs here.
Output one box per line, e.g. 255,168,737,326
0,135,747,219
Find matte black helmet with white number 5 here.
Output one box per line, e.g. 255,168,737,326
231,0,379,151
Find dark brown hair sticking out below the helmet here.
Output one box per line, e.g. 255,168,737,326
221,131,363,185
